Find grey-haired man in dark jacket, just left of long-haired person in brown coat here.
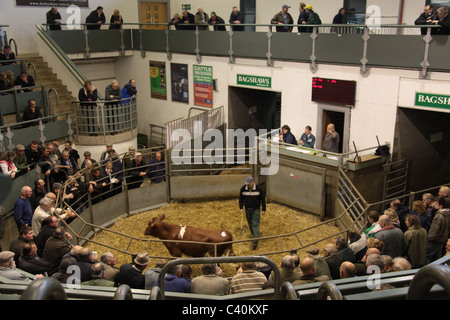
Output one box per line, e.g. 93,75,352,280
373,215,406,258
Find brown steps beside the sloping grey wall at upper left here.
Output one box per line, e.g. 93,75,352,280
20,54,77,120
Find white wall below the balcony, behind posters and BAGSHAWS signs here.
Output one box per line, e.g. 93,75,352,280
116,46,450,155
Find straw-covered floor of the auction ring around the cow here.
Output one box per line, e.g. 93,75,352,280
86,199,340,276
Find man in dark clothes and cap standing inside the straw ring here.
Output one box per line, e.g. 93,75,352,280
239,177,266,250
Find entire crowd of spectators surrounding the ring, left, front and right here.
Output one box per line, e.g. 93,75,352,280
0,141,450,295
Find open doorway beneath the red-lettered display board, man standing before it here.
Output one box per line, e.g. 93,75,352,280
316,105,350,153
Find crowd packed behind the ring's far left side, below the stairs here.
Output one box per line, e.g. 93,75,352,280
0,140,165,202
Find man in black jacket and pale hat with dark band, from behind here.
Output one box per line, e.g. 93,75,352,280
116,252,150,289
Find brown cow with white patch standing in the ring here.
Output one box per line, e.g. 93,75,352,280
144,214,234,257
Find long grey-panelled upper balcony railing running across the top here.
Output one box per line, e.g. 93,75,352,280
40,23,450,76
